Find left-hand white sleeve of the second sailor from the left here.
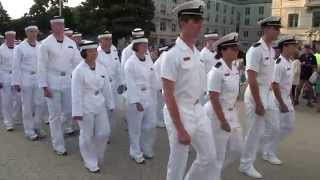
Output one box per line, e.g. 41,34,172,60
11,47,23,85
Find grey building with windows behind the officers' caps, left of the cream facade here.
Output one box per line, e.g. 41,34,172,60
151,0,272,48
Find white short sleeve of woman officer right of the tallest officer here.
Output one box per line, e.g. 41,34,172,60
208,67,223,93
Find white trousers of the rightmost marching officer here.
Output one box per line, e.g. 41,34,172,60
264,110,294,155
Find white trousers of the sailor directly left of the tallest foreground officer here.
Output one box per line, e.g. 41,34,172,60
127,104,156,158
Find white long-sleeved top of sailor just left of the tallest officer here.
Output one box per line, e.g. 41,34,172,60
125,54,155,107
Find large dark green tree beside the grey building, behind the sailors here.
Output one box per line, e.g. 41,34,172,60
75,0,155,40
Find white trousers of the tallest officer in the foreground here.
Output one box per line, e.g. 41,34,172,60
163,103,219,180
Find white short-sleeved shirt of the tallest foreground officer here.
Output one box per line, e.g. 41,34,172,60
161,37,206,104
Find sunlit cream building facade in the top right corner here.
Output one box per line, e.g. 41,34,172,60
272,0,320,47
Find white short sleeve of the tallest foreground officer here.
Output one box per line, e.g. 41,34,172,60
161,54,178,81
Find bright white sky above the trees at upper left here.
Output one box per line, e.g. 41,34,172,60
0,0,84,19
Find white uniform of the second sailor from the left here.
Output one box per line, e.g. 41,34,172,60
12,40,44,137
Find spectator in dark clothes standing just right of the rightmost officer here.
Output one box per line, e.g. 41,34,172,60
295,45,317,107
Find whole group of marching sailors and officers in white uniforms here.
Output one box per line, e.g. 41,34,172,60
0,0,304,180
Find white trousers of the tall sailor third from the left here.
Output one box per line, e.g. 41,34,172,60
46,89,71,152
